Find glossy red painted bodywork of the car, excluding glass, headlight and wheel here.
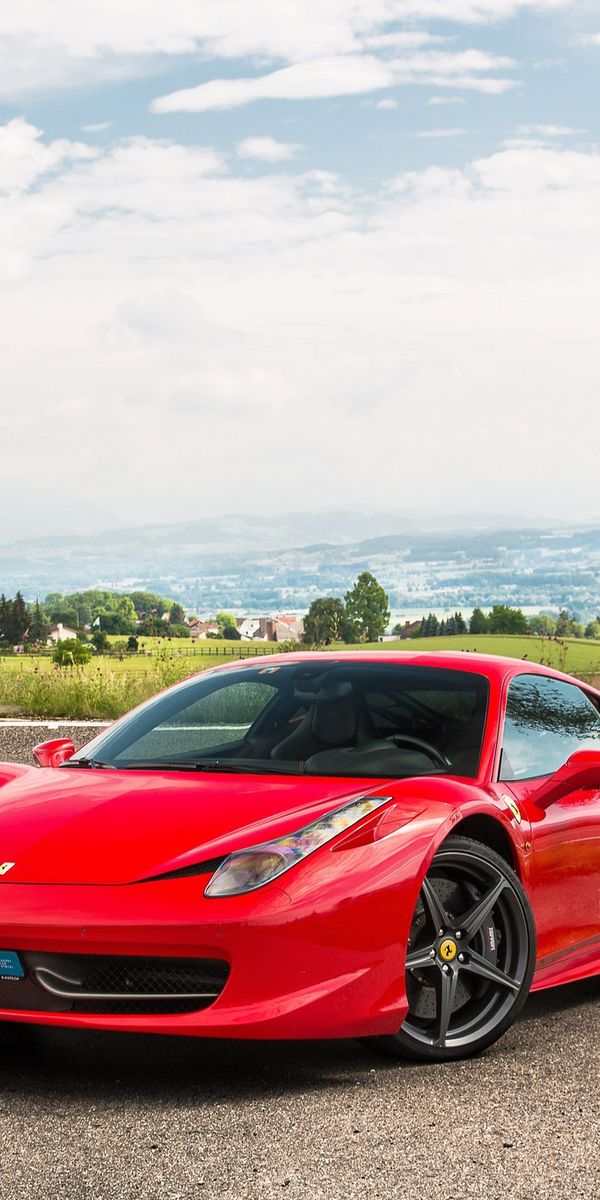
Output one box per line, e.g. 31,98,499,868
0,653,600,1038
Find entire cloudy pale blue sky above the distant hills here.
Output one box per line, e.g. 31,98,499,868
0,0,600,540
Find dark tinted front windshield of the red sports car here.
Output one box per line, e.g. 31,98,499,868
64,658,488,779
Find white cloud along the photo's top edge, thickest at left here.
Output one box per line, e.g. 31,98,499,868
0,0,566,97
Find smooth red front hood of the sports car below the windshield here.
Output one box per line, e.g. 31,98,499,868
0,768,385,888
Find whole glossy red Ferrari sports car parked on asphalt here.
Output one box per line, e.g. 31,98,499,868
0,650,600,1060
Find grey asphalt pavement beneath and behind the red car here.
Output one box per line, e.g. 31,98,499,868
0,727,600,1200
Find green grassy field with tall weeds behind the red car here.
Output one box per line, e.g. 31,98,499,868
0,634,600,720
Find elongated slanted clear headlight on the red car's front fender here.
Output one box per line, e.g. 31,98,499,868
204,796,391,896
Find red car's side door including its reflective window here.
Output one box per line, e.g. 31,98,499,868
499,674,600,967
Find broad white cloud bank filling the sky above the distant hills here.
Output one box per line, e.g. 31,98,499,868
0,115,600,520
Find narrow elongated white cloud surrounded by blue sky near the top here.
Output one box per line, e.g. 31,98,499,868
151,50,516,113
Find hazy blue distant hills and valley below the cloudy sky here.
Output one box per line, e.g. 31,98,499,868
0,510,600,619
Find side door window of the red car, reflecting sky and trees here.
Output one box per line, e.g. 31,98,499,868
500,674,600,780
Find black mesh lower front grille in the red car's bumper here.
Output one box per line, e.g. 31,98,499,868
0,952,229,1014
